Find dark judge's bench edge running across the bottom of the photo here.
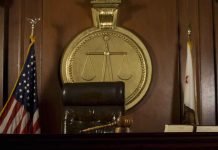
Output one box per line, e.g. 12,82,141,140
0,133,218,150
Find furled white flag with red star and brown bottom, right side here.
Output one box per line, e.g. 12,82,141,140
184,39,198,124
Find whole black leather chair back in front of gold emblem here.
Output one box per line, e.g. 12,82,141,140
62,81,125,134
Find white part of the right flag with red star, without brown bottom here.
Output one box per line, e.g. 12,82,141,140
184,40,198,123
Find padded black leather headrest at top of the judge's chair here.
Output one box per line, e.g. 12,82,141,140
62,81,125,106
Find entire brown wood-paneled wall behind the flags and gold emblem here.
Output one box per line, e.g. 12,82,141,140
0,0,218,133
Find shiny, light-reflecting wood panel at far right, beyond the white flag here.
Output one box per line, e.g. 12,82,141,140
199,0,216,125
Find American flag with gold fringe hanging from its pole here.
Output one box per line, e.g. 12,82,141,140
0,36,40,134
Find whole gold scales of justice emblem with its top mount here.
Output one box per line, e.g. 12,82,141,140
61,0,152,110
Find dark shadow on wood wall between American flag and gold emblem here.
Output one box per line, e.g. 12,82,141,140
40,25,64,134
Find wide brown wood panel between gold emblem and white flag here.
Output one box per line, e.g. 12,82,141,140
120,0,180,132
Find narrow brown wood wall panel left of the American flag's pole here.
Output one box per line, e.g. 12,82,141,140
7,0,23,99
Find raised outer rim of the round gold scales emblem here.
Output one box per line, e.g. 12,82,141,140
60,27,152,110
